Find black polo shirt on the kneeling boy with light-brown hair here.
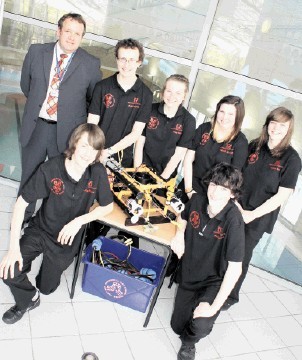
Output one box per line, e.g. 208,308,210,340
21,155,113,242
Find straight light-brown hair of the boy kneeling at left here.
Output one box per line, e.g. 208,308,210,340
64,123,105,162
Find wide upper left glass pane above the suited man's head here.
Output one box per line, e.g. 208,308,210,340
5,0,210,59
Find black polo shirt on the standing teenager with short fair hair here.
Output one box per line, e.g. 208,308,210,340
143,103,196,174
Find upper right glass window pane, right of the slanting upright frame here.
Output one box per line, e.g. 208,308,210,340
202,0,302,91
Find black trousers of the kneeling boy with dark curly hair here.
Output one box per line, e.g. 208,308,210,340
171,286,220,345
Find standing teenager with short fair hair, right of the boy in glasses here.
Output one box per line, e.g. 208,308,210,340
134,74,196,179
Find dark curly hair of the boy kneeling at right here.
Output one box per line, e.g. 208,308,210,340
203,163,243,200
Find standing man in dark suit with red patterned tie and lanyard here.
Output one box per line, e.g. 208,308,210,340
19,13,101,221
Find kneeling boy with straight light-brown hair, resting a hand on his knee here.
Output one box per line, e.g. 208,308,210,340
0,124,112,324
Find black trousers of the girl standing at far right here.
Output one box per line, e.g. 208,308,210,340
227,224,263,304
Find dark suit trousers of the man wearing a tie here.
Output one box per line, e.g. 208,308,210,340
18,118,60,221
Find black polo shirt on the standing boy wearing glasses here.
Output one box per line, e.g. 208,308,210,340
89,73,153,166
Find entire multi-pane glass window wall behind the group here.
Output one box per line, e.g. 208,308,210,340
0,0,302,285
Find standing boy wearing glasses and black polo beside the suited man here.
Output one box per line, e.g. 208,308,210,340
88,39,152,167
